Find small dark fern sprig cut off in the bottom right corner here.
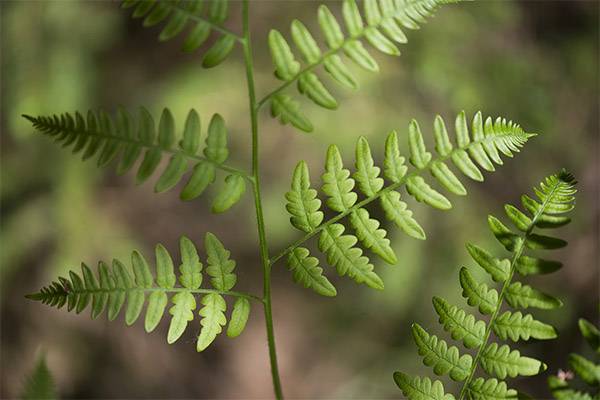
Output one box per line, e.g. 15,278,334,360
548,304,600,400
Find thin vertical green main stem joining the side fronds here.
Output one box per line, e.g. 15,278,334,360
243,0,283,399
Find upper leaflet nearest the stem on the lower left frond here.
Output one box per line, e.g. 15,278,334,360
206,232,237,291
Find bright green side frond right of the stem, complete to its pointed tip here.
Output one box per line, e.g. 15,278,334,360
278,112,533,295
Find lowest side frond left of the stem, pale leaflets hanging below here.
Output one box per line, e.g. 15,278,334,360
27,233,262,351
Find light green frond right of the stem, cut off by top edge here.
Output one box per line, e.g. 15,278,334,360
259,0,456,132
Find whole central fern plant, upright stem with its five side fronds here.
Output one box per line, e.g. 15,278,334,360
24,0,540,398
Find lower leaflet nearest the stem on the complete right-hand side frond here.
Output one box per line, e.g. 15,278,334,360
286,247,337,296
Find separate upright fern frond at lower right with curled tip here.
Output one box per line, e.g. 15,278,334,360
394,170,575,399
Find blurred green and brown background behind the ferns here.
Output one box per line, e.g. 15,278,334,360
0,1,599,399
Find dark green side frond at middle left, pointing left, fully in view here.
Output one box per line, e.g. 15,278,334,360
24,107,251,212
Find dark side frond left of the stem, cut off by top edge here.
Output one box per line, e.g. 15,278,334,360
121,0,242,68
